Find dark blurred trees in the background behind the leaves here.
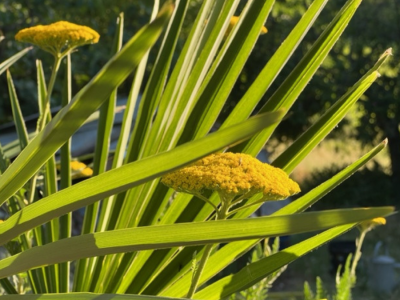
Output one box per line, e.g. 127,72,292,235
0,0,400,205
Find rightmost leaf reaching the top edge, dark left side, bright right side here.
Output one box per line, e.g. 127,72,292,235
234,0,361,156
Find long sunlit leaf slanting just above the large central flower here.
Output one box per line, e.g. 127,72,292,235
0,111,283,243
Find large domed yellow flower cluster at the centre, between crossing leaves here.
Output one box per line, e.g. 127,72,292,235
162,153,300,200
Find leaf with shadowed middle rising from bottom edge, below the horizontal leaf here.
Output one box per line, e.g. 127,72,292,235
193,223,357,300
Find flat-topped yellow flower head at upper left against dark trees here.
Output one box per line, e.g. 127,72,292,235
15,21,100,56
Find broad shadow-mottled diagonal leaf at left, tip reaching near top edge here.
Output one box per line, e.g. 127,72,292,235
0,4,173,207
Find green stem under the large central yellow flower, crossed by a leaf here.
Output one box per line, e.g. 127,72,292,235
187,193,232,299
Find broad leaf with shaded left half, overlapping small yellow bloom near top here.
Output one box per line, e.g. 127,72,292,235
180,0,274,143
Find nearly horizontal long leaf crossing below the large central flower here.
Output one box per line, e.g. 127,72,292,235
0,207,394,278
